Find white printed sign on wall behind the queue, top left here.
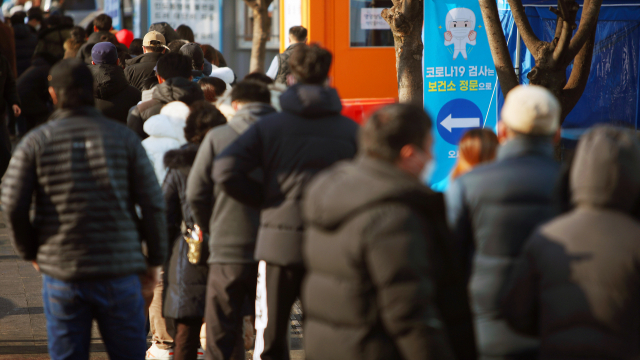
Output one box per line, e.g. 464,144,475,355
149,0,220,49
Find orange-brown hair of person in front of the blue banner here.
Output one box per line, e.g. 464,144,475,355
451,129,498,179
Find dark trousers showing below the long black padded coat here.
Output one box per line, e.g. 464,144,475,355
165,318,202,360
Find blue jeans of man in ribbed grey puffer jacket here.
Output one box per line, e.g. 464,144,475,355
42,275,147,360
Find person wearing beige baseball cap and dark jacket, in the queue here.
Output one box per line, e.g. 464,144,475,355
124,31,167,91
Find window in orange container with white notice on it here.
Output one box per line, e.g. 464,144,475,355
349,0,394,47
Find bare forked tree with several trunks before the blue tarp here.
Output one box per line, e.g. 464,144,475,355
479,0,602,122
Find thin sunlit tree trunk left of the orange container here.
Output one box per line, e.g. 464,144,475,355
244,0,273,73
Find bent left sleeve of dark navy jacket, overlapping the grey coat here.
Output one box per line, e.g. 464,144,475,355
213,123,264,208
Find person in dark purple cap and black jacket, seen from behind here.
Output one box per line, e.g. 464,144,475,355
89,42,141,124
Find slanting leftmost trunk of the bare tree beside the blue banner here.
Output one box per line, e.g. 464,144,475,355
479,0,519,97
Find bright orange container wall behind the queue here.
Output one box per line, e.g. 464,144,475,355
281,0,398,99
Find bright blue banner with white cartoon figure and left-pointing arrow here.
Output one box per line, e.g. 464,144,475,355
424,0,498,191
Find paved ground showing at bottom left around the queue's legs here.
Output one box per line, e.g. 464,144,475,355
0,214,304,360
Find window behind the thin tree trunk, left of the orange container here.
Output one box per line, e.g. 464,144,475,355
236,0,280,50
